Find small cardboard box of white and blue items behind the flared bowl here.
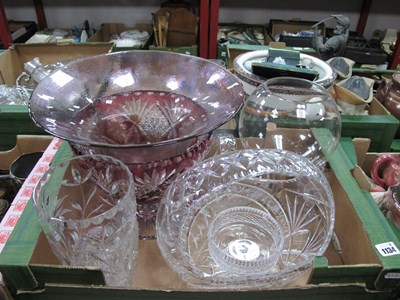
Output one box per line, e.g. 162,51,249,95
88,23,154,52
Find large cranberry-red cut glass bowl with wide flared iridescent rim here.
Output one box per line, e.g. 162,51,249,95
29,50,244,238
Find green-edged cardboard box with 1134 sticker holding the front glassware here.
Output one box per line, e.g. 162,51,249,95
0,142,400,299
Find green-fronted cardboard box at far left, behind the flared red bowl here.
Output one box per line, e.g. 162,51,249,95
0,43,113,151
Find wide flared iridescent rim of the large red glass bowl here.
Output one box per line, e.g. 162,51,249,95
28,50,245,148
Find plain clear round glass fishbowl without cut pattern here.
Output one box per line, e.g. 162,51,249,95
238,77,342,169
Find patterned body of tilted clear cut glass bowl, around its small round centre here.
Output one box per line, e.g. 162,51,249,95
156,149,334,289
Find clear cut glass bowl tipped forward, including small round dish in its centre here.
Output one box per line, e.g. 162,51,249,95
156,149,335,290
